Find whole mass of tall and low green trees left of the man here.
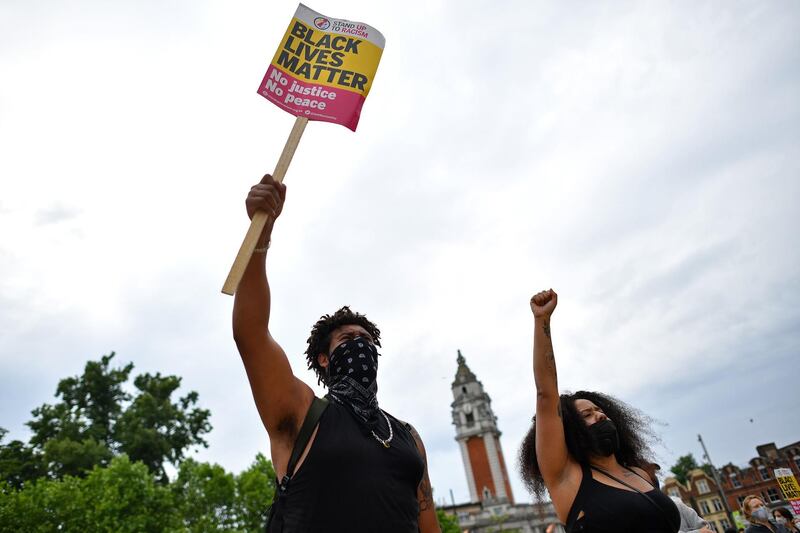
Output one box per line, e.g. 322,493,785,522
0,353,275,533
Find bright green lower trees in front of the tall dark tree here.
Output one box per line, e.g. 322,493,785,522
0,454,275,533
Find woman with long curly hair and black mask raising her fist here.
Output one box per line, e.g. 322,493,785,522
520,289,680,533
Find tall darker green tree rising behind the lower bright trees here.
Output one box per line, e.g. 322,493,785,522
14,352,211,487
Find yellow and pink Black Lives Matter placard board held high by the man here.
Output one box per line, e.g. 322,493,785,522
258,4,386,131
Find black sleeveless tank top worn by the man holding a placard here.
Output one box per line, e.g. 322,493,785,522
283,401,424,533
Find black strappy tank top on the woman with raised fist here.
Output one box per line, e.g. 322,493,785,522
567,465,681,533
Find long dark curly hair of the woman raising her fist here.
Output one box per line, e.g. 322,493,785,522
519,391,658,500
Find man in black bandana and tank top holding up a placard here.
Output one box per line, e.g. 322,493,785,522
233,175,440,533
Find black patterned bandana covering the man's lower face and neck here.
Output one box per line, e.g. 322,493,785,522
328,337,381,430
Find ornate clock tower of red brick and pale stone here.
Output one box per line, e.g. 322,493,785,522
450,350,514,504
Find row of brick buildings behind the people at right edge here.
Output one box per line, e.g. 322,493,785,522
662,442,800,532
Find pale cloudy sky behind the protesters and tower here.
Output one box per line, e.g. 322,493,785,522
0,0,800,501
